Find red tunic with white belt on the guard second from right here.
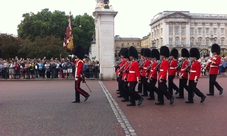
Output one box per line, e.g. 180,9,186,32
189,60,201,80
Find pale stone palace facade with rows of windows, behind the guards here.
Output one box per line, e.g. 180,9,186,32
150,11,227,54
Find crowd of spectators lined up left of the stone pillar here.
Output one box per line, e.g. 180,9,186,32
0,57,99,79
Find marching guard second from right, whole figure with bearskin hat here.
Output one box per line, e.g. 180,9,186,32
185,48,206,103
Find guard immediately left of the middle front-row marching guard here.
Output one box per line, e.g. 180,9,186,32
147,49,160,100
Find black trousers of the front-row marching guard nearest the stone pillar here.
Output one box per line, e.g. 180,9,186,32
129,82,141,104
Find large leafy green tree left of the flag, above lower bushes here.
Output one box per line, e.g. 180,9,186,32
18,9,68,41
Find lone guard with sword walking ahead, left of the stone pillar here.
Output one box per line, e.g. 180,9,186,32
72,45,90,103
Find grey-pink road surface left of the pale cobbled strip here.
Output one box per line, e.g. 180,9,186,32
0,80,125,136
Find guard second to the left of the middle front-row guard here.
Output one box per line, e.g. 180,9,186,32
141,48,151,96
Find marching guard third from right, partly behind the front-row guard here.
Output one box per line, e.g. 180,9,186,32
176,48,190,99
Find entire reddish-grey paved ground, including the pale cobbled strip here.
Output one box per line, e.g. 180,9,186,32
0,77,227,136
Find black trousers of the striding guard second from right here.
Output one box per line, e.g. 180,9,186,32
188,80,204,102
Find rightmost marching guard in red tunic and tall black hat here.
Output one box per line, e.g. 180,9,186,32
206,44,223,95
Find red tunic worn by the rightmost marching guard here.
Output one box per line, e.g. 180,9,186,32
206,55,221,75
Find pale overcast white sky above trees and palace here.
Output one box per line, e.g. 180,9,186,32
0,0,227,38
